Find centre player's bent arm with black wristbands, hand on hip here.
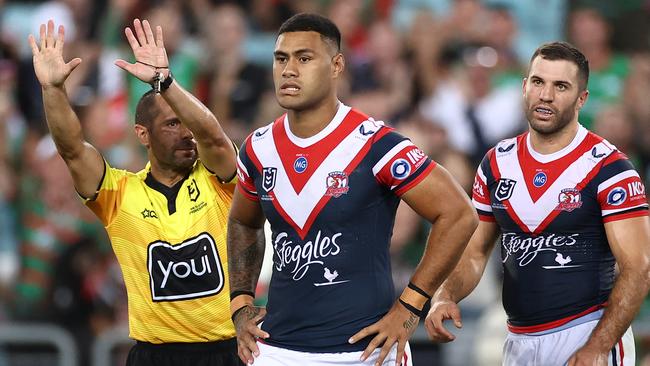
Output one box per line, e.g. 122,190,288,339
350,166,478,364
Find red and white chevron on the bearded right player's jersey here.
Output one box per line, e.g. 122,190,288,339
491,129,615,233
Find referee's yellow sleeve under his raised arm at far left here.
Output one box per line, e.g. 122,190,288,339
84,160,130,226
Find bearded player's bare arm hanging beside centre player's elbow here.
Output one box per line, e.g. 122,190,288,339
424,221,499,342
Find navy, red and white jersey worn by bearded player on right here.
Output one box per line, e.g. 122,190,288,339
472,126,648,333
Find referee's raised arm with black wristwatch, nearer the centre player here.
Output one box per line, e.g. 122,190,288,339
115,19,236,180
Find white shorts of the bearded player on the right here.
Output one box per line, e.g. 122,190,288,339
503,320,635,366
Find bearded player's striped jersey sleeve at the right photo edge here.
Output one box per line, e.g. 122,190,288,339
597,152,648,222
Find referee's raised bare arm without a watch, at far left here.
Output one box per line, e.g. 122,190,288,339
29,20,105,198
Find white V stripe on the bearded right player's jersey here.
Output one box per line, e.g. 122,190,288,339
495,138,614,232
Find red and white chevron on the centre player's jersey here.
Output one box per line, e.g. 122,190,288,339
247,105,390,239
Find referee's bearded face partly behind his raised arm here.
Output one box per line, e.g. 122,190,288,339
147,96,198,172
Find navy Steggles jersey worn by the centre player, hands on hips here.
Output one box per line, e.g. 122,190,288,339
238,104,435,352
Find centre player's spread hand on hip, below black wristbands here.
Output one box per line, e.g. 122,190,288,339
349,301,420,365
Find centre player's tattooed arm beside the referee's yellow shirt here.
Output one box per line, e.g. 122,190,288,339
228,189,269,364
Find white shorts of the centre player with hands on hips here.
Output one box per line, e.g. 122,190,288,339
253,342,413,366
